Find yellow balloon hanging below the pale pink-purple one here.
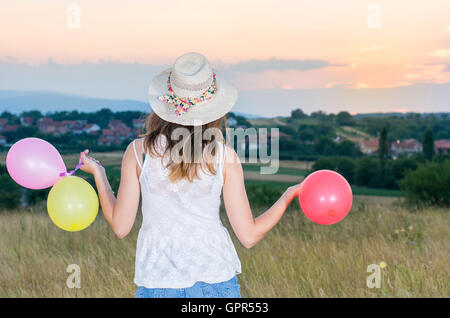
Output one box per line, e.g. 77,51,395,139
47,176,98,232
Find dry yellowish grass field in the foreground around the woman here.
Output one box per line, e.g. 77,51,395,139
0,199,450,297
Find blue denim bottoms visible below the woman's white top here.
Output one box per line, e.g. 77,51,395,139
136,276,241,298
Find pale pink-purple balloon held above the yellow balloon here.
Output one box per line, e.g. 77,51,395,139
6,138,67,190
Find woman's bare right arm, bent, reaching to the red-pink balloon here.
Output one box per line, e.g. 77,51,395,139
223,148,301,248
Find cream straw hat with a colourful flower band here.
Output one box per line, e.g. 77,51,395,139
148,53,237,126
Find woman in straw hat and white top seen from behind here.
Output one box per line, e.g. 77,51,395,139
80,53,300,297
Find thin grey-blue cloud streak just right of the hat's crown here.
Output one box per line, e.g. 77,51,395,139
229,58,347,73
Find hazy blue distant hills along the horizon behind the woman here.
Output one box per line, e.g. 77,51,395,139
0,90,262,119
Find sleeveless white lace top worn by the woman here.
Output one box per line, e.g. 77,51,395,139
133,135,241,288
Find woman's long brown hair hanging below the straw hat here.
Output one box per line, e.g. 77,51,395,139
140,112,227,182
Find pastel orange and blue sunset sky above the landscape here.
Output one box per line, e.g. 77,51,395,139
0,0,450,115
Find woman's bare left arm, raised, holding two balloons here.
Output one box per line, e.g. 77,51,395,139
80,140,140,238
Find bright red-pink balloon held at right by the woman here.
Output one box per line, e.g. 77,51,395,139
298,170,353,225
